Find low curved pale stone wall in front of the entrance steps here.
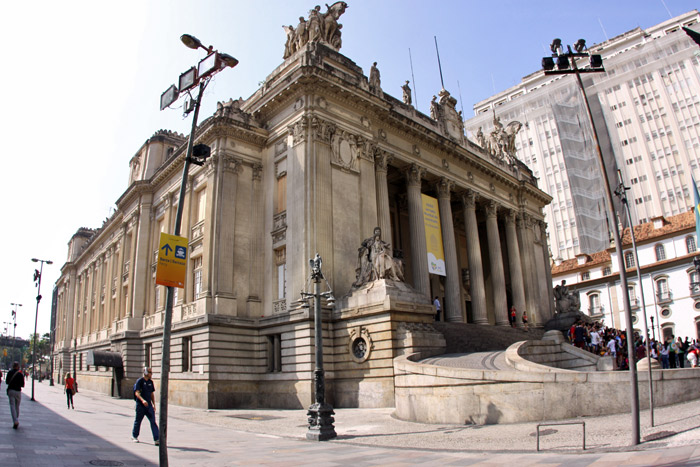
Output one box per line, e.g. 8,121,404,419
394,344,700,425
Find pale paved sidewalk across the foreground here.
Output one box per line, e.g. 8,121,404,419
0,381,700,467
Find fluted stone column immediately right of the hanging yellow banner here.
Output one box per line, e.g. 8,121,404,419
436,178,464,323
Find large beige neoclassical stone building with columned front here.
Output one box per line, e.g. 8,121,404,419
54,5,553,408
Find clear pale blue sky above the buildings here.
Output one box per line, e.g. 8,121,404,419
0,0,697,337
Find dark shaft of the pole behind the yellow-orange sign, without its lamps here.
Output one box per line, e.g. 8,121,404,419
158,79,204,467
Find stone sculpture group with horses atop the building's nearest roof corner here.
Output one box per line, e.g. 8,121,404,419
282,2,348,59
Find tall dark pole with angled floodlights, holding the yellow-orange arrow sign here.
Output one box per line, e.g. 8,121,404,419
158,34,238,467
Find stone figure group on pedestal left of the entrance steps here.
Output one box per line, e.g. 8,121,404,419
352,227,404,288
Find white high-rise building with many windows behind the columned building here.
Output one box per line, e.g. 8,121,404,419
465,10,700,260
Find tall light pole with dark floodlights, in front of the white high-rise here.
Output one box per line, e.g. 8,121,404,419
542,39,640,445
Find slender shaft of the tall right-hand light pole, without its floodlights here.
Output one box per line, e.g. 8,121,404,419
568,46,640,445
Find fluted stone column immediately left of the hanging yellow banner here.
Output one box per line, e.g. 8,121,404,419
406,164,430,298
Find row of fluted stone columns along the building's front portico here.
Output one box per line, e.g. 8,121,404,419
375,156,552,326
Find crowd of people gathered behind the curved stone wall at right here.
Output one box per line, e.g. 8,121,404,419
567,320,700,370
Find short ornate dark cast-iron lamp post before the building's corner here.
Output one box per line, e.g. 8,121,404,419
301,253,338,441
